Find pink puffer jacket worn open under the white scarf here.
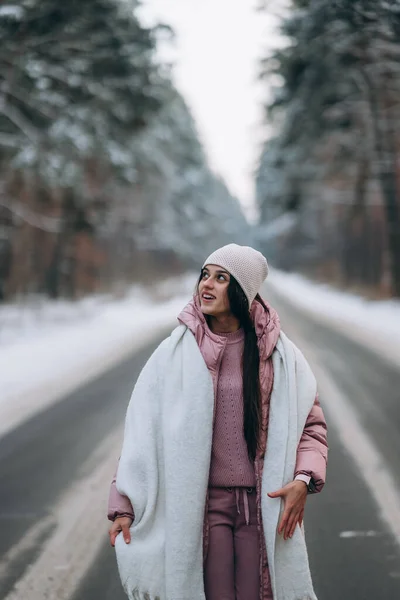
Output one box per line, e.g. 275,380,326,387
108,298,328,600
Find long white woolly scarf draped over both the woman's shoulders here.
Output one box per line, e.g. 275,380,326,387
115,325,316,600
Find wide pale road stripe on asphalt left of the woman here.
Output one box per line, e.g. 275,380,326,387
4,427,123,600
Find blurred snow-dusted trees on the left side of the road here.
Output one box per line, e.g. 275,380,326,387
0,0,248,300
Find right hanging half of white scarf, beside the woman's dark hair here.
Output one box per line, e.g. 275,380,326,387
261,332,317,600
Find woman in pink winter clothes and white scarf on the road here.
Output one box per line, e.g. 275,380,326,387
108,244,327,600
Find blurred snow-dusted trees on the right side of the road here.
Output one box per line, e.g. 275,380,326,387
257,0,400,296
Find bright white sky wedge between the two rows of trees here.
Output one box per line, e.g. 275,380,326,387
140,0,280,219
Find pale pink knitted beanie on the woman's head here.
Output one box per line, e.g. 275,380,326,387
203,244,268,307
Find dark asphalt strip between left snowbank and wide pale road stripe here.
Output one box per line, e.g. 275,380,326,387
0,332,170,600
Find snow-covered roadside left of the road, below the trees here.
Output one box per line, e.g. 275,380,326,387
0,274,196,435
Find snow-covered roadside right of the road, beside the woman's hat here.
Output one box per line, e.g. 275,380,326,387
266,269,400,368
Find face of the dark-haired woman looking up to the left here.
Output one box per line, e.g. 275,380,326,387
199,265,231,317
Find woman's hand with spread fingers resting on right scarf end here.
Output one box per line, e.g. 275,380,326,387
268,480,307,540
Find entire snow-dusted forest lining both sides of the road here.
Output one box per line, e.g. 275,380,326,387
0,0,400,302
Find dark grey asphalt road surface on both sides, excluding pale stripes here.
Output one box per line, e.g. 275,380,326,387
0,298,400,600
